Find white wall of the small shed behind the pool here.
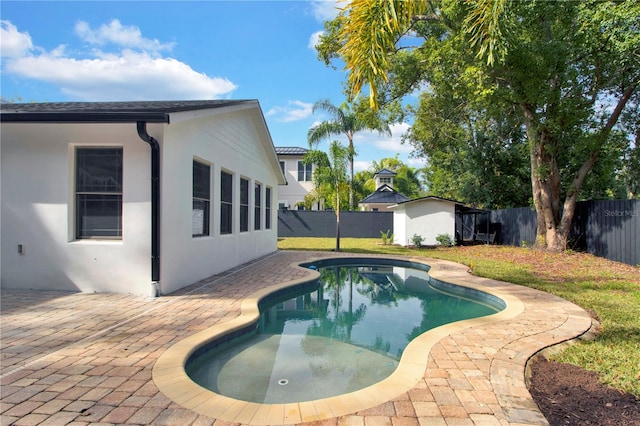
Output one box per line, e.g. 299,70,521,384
393,199,455,245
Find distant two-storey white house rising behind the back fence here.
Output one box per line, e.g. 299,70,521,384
276,146,322,210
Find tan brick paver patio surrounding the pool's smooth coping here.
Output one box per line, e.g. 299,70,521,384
0,251,590,426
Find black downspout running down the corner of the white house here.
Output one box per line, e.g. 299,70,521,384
137,121,160,297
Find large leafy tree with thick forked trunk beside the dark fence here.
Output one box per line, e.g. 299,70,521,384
319,0,640,250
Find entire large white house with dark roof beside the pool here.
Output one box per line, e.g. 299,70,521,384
0,100,285,295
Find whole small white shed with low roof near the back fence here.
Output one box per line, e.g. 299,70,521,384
389,196,482,246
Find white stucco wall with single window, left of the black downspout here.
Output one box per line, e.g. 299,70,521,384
1,123,151,295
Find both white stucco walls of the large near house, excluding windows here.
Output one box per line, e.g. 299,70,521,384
0,105,282,296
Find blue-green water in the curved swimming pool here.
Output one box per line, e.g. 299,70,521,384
186,259,505,404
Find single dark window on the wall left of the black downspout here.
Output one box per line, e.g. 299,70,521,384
75,147,122,239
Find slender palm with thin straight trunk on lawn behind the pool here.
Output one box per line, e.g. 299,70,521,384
302,141,349,251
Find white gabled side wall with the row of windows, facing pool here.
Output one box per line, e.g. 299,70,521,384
158,110,279,294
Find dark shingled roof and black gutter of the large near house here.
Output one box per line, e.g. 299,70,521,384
0,100,258,123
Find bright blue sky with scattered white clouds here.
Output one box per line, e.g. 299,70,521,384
0,0,423,170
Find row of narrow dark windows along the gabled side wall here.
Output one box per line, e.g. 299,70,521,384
192,160,271,237
